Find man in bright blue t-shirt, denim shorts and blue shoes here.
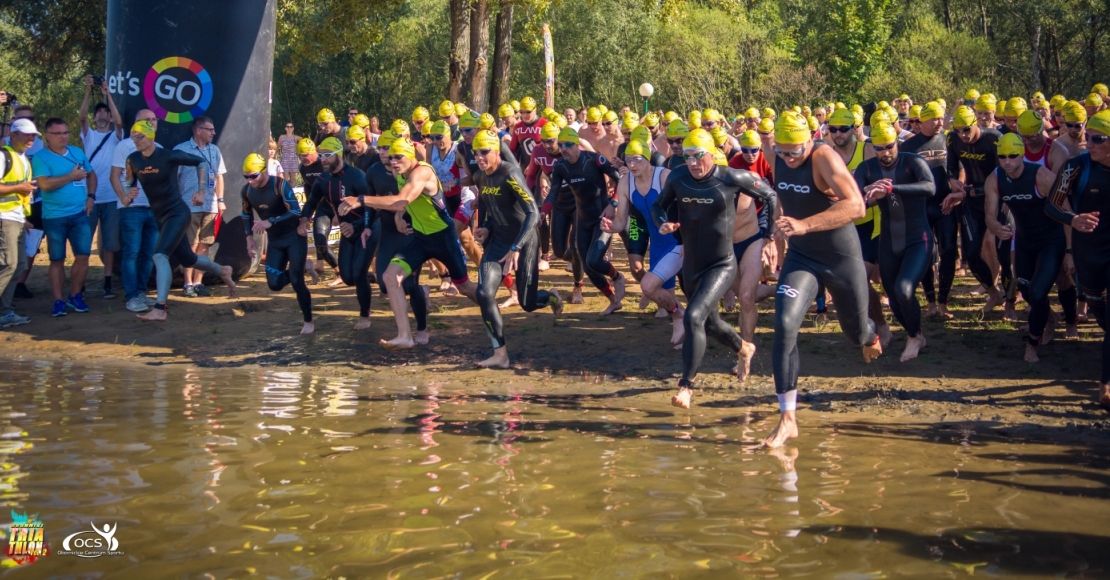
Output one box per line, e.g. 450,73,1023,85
31,116,97,317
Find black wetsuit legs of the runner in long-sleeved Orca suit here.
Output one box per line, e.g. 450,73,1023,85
679,262,740,386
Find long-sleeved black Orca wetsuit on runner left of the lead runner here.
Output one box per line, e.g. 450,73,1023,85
652,165,777,386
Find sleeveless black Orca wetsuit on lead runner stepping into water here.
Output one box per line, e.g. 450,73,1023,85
771,144,875,394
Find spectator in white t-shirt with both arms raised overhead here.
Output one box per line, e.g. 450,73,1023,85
78,77,123,298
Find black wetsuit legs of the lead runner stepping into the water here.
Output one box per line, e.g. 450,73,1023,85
771,251,875,393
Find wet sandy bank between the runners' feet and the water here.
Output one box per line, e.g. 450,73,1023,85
0,252,1110,444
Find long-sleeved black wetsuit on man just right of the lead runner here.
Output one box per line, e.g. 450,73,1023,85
855,152,936,337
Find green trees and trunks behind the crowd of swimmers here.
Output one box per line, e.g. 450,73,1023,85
0,0,1110,132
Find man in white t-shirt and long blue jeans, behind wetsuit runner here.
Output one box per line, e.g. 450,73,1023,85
111,109,161,313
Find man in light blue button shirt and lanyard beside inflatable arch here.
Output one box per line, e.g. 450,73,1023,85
173,116,228,298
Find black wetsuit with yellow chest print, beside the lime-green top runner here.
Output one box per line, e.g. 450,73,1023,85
473,163,552,348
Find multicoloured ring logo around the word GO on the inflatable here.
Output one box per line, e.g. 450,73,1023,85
142,57,212,124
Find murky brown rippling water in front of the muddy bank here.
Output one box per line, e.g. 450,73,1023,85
0,364,1110,577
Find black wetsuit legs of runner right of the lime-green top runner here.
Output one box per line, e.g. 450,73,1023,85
476,236,552,348
